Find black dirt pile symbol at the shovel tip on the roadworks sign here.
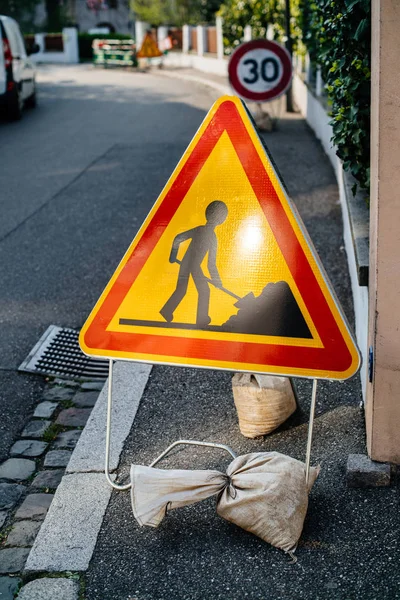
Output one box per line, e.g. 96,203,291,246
221,281,312,339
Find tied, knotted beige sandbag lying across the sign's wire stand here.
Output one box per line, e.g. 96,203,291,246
131,452,319,552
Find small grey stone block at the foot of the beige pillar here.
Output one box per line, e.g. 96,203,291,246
346,454,390,488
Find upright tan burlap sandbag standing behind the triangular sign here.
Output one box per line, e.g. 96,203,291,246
232,373,296,438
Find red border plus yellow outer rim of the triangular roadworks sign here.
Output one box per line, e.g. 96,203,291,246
80,96,361,380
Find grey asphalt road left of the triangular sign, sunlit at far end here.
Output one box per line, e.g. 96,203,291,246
0,66,216,460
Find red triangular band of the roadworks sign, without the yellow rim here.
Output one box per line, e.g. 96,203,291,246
83,99,359,378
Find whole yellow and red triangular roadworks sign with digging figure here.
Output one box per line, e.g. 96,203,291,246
80,96,360,379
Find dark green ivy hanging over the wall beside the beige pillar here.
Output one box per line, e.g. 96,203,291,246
303,0,371,192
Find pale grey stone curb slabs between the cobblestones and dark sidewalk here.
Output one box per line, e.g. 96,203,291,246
25,361,152,574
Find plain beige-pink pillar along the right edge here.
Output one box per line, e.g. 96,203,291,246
366,0,400,463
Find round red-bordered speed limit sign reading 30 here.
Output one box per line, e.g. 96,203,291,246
228,40,292,102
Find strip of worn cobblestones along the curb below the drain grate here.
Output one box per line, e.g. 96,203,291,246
0,379,104,600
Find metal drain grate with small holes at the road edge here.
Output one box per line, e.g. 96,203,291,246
18,325,108,379
